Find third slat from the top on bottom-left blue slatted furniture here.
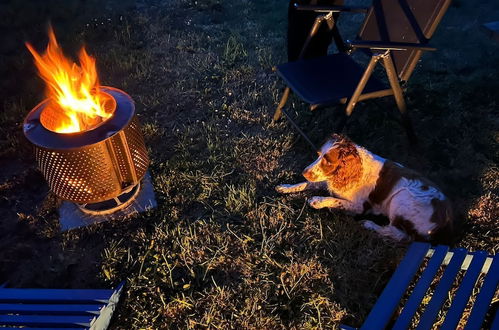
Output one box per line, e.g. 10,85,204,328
0,315,94,327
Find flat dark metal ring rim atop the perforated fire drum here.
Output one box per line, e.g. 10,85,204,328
23,86,135,151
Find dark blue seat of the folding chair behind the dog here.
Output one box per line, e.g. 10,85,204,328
277,54,389,105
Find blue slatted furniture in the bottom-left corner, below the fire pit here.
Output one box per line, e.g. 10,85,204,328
0,282,125,330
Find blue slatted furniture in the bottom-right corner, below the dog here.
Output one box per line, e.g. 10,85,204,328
342,243,499,330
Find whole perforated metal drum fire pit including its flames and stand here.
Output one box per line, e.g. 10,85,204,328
24,29,154,222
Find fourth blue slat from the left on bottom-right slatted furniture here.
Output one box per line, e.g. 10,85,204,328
440,251,488,330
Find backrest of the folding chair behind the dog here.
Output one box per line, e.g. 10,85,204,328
358,0,451,81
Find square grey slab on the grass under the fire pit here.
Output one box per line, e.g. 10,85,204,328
59,173,157,231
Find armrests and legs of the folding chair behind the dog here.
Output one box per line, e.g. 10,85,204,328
273,4,442,143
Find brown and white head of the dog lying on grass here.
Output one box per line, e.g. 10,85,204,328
303,134,362,187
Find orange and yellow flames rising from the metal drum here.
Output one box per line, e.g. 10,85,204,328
26,27,114,133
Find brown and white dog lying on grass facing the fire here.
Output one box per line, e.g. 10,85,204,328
276,134,453,242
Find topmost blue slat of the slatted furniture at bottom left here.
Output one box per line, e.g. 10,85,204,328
0,289,114,303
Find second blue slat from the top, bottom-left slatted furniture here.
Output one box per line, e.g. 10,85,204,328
0,304,105,315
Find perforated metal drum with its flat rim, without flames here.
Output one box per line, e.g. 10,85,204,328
24,87,149,204
